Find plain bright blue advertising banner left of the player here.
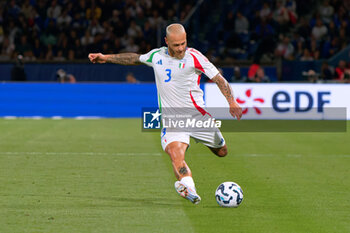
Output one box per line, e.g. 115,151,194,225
0,83,158,118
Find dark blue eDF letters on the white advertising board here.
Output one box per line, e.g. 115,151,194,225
272,91,331,112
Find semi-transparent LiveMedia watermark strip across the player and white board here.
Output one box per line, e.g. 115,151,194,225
142,107,347,133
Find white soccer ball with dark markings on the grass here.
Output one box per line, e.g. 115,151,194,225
215,182,243,207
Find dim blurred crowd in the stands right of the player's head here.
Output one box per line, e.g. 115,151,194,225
205,0,350,61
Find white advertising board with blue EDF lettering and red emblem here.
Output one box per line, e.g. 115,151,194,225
205,83,350,120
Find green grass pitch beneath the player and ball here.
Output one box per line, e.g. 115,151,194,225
0,119,350,233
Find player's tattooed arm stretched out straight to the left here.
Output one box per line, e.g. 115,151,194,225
89,53,142,65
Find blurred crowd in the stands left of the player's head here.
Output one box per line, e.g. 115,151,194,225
0,0,195,61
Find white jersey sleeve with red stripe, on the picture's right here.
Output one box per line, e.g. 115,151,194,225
189,48,219,79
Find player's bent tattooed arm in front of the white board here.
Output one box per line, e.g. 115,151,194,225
212,73,242,120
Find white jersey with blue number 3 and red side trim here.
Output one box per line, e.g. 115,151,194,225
140,47,219,115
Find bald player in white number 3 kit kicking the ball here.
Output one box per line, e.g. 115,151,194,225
89,24,242,204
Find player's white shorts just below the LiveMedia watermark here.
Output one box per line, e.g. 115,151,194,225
160,128,225,151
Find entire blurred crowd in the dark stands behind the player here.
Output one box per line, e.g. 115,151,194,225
0,0,350,74
